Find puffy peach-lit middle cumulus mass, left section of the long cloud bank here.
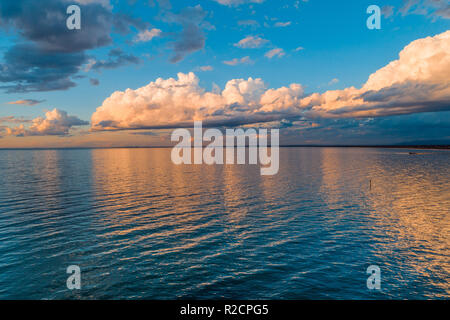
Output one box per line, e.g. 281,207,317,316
92,73,303,130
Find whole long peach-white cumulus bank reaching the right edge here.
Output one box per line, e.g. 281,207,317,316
91,31,450,130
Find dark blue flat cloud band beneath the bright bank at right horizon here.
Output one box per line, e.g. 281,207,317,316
280,111,450,145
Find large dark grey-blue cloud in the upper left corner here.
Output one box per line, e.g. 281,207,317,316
0,0,148,92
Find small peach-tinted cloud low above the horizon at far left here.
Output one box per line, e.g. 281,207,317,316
5,109,89,137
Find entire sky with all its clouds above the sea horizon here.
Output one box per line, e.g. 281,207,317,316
0,0,450,148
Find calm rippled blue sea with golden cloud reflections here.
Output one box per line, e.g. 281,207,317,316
0,148,450,299
